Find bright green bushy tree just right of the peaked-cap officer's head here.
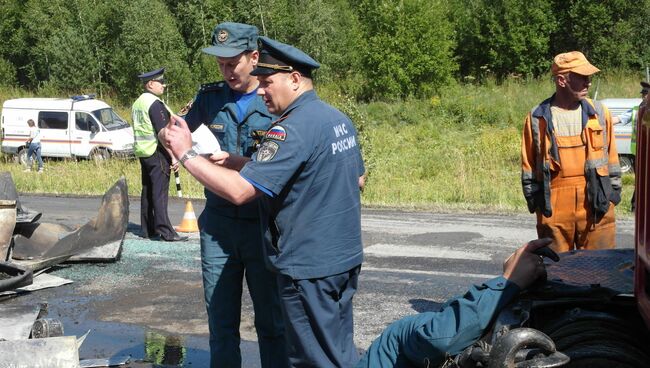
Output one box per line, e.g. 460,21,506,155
353,0,458,99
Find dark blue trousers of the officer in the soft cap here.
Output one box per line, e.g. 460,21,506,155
199,207,288,368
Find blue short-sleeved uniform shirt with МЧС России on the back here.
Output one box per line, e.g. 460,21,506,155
241,91,364,279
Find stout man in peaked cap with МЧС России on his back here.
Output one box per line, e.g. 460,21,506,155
161,37,364,367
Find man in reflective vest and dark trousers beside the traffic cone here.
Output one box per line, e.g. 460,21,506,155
132,68,187,241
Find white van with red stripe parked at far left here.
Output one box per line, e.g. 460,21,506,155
0,95,133,163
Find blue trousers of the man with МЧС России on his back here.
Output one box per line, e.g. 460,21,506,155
278,266,361,368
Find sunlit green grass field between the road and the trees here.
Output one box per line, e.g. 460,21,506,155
0,74,642,216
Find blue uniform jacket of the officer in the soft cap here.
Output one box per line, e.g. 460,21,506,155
185,82,275,218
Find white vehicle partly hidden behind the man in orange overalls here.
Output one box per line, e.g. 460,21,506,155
600,98,641,172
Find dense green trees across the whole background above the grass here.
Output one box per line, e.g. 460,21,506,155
0,0,650,103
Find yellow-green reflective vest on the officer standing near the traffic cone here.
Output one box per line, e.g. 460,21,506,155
132,93,172,157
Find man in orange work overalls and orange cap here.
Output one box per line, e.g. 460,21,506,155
521,51,621,252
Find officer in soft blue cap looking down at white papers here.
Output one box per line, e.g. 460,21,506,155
180,22,288,368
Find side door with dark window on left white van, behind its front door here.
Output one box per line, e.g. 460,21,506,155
38,111,70,157
